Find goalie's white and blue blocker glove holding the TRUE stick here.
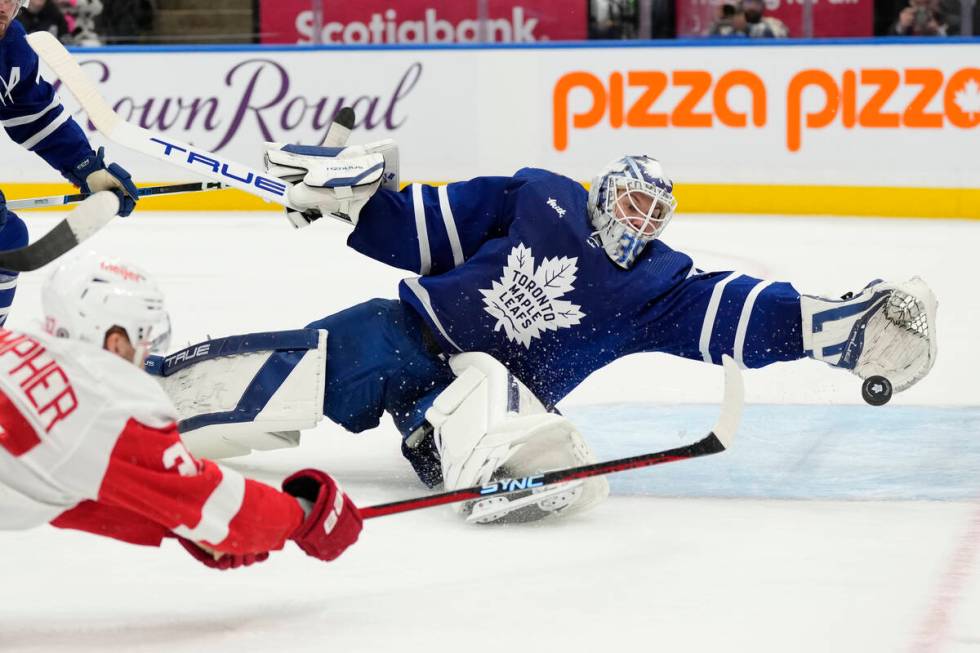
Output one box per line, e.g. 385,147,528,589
265,139,399,227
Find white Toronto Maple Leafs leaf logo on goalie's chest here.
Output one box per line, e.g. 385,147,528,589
480,243,585,349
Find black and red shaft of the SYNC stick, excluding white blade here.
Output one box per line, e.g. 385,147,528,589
360,433,725,519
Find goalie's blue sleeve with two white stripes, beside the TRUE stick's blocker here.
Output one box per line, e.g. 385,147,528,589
347,177,523,275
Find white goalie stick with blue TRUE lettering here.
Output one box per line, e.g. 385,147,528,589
27,32,295,208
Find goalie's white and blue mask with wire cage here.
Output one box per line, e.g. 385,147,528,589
588,156,677,268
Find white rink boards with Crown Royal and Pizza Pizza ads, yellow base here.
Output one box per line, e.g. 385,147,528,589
0,39,980,218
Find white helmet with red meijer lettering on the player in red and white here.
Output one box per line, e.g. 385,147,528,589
41,252,170,351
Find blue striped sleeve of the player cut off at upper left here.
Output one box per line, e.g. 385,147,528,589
0,21,92,176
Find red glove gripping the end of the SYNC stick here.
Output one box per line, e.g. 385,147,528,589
282,469,362,561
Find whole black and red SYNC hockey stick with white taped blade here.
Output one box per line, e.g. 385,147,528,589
360,356,745,519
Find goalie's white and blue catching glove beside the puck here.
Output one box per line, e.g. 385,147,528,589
800,277,937,392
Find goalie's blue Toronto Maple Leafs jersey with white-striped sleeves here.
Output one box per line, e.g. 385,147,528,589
348,168,804,405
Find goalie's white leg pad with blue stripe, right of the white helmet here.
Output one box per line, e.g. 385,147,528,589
146,329,327,458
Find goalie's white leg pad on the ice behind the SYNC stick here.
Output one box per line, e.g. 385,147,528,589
426,352,609,523
